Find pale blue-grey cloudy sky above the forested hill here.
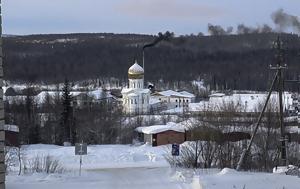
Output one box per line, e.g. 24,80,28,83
2,0,300,35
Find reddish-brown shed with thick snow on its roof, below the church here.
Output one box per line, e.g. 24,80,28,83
136,122,186,146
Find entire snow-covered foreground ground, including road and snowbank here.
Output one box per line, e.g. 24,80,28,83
6,144,300,189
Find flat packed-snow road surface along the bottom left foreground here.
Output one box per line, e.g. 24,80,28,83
6,167,196,189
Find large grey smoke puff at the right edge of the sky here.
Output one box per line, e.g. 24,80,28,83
271,9,300,33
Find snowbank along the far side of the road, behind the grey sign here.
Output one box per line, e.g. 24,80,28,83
22,144,169,170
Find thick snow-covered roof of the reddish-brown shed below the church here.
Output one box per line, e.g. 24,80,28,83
135,122,185,134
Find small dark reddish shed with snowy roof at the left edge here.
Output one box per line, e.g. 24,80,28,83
4,124,19,146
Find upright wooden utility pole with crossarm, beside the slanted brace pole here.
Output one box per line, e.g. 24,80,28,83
271,37,288,166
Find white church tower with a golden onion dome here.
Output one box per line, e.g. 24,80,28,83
121,61,150,114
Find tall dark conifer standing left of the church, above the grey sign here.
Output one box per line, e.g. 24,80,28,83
61,79,75,144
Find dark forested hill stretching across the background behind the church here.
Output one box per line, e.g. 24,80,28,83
3,33,300,90
